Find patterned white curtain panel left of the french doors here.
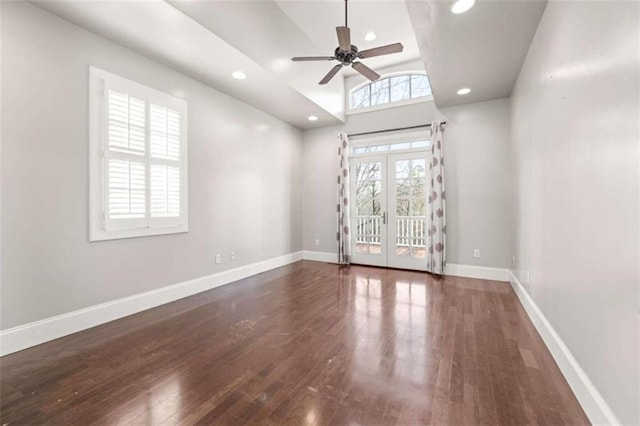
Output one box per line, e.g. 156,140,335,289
337,133,351,264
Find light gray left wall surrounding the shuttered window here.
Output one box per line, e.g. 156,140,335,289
0,3,302,329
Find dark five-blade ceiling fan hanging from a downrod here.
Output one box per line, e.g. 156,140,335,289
291,0,404,84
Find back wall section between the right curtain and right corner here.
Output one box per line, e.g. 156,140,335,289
440,99,510,269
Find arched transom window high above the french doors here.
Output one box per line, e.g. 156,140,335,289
350,73,431,110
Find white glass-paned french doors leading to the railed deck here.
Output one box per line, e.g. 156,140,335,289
350,151,429,270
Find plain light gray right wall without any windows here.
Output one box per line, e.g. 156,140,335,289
510,1,640,424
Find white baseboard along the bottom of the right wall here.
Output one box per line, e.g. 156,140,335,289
510,272,621,425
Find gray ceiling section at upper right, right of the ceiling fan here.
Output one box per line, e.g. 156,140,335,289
406,0,547,108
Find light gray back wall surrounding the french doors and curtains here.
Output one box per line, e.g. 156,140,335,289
303,99,509,268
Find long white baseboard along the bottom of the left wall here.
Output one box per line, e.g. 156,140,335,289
0,251,302,356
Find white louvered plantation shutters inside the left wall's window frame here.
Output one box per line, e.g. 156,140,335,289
103,80,186,231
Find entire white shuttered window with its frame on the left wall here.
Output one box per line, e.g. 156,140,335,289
89,67,188,241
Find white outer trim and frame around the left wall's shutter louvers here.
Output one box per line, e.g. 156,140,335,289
88,66,189,242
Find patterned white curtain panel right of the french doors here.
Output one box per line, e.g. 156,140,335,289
427,121,447,274
